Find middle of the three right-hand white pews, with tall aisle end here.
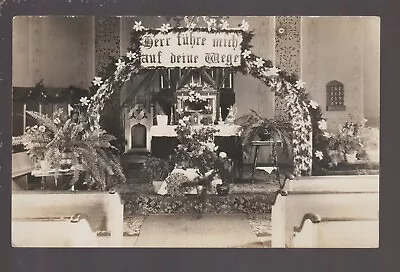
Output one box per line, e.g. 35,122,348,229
271,191,379,247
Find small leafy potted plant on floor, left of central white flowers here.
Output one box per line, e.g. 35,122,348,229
144,156,173,193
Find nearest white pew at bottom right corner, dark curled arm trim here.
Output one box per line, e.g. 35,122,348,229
292,213,379,248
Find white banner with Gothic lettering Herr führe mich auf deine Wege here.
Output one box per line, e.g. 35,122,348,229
140,30,243,68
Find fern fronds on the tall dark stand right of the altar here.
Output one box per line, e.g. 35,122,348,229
235,110,292,157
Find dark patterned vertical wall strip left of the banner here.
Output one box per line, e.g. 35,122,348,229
95,17,120,74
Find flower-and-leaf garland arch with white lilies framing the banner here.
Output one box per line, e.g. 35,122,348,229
88,19,326,175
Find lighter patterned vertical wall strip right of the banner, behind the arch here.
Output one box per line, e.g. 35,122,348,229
275,16,301,118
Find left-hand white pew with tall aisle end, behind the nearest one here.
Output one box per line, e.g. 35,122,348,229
11,191,123,242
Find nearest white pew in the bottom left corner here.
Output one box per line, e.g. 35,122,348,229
11,214,97,247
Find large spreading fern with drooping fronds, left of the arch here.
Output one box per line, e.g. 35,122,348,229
13,111,126,190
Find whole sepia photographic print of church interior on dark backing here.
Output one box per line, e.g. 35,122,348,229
11,15,380,249
